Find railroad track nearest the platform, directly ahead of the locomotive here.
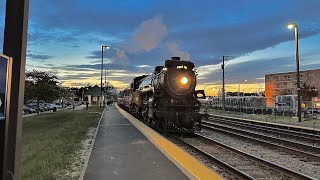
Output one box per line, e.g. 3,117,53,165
175,133,313,180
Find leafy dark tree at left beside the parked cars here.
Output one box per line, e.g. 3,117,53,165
25,70,61,113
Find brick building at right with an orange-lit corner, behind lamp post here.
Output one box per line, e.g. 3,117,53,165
265,69,320,108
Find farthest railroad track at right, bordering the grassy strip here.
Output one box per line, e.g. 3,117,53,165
209,116,320,146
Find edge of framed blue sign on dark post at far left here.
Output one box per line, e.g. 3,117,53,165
0,54,10,120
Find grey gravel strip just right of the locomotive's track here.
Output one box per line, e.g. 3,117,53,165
201,129,320,179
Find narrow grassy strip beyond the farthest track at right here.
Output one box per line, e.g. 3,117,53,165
208,109,320,128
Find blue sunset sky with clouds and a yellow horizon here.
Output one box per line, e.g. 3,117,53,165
0,0,320,93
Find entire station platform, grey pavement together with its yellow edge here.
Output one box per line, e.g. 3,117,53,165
84,106,222,180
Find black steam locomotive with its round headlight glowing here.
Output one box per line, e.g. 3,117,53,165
119,57,205,133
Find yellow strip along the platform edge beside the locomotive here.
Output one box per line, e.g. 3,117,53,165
116,105,223,180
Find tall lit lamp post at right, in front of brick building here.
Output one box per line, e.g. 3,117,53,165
288,23,301,122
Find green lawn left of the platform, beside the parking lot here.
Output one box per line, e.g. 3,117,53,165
20,108,101,180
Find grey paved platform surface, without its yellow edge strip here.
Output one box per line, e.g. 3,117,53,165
84,106,188,180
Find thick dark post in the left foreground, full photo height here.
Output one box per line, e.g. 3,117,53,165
0,0,29,180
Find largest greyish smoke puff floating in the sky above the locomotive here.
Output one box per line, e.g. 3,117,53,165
127,16,168,53
